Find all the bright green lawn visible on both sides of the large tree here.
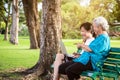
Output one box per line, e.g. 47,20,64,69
0,35,120,71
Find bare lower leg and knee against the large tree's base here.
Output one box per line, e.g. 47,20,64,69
53,53,64,80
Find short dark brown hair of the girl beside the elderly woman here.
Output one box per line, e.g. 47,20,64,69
80,22,96,37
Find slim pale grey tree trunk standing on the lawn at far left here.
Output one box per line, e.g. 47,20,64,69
10,0,19,44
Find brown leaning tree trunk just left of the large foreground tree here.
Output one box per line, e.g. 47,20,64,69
22,0,40,49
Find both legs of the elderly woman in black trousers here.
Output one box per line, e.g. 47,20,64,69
59,61,92,80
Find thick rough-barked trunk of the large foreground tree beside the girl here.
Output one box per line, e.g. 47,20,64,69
22,0,61,80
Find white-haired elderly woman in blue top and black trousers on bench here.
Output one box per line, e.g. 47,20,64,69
59,17,110,80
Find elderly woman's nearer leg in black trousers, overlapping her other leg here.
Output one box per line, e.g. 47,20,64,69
66,61,93,80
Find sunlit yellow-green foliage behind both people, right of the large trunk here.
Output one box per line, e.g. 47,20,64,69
61,0,116,39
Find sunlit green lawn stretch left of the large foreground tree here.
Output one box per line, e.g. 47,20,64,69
0,37,39,71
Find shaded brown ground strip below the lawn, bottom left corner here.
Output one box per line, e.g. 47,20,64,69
0,68,39,80
